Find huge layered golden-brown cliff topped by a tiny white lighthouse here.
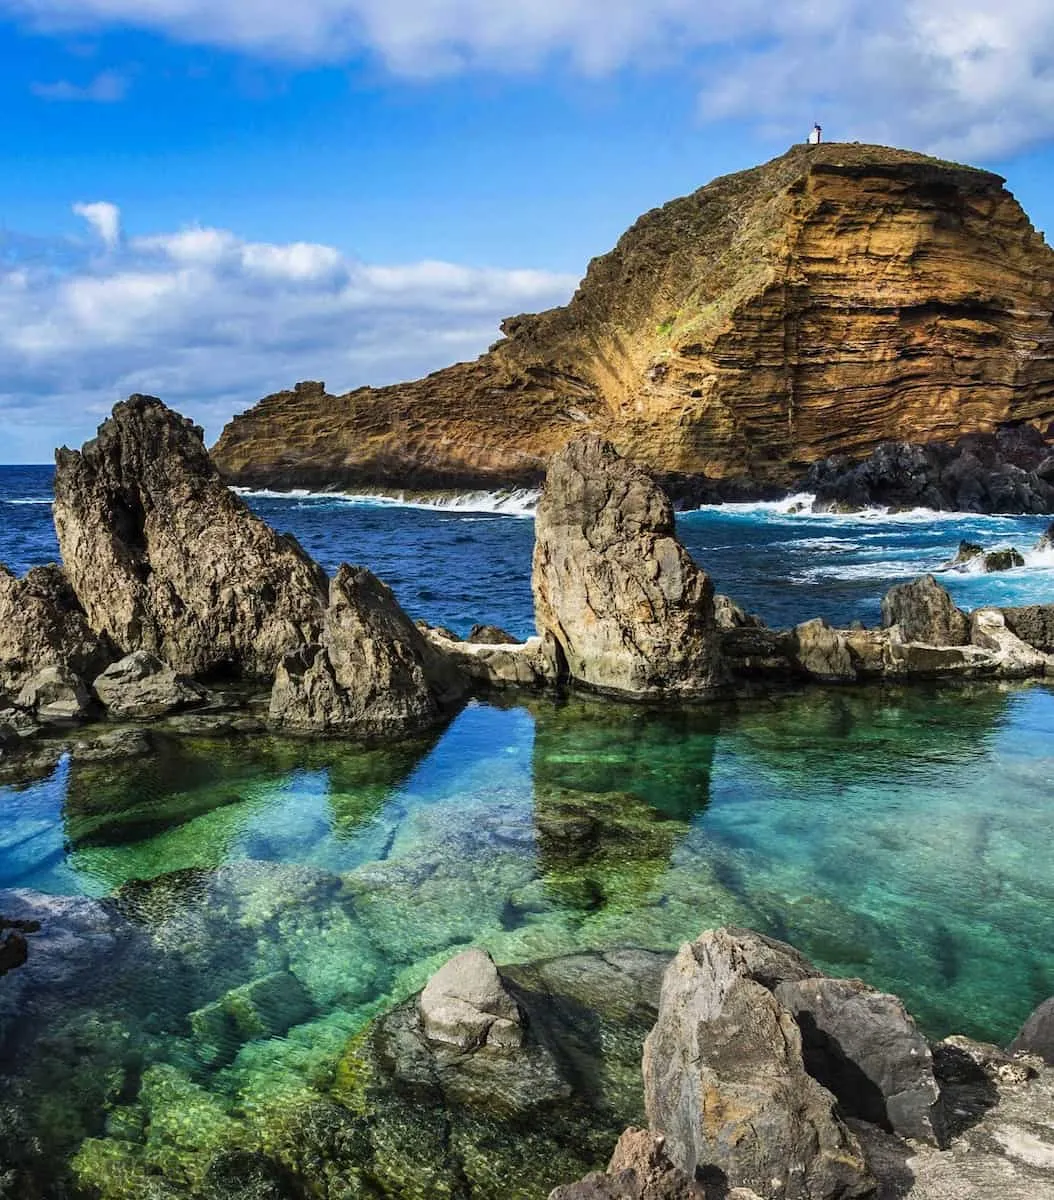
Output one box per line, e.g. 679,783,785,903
212,144,1054,488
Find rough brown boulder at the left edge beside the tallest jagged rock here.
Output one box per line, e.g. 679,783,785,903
0,564,113,695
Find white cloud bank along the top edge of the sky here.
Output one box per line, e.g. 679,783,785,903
0,0,1054,156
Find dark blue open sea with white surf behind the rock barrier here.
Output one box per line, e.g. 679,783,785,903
0,467,1054,636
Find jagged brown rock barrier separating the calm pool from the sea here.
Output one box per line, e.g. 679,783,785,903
0,396,1054,758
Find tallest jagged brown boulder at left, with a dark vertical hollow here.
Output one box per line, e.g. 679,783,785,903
55,396,327,678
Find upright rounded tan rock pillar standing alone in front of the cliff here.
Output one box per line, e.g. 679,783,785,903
532,434,721,697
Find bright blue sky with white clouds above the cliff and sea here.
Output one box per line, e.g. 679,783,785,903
0,0,1054,462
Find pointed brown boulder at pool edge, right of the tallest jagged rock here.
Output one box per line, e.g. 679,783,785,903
270,565,467,737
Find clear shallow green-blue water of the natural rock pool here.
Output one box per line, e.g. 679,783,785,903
0,686,1054,1196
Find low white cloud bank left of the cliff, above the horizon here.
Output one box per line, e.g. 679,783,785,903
0,203,576,461
